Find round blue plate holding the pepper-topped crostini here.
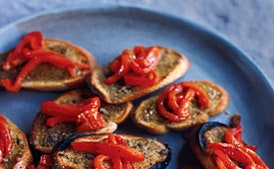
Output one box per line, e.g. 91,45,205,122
0,4,274,169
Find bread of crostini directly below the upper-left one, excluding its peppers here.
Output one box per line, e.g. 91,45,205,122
30,89,133,153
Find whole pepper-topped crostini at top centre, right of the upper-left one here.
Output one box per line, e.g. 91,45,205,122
89,46,190,104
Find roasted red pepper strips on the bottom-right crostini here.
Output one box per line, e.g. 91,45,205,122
207,124,268,169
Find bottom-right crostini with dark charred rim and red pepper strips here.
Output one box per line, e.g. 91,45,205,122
188,115,269,169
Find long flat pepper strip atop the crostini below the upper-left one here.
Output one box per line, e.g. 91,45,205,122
41,97,101,117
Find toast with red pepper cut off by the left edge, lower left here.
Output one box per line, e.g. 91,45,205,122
0,114,33,168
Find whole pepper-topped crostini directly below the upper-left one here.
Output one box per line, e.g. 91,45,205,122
29,89,133,153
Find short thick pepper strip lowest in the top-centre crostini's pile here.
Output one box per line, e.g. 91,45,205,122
124,70,158,86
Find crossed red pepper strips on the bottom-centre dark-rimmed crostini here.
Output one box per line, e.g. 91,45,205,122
71,134,145,169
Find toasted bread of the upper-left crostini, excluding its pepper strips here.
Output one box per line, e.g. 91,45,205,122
0,39,97,91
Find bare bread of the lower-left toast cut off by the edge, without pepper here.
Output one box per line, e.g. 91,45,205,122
0,114,33,168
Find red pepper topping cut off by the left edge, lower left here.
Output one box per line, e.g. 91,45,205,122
0,115,13,162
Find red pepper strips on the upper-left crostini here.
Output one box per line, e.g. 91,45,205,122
1,32,91,92
